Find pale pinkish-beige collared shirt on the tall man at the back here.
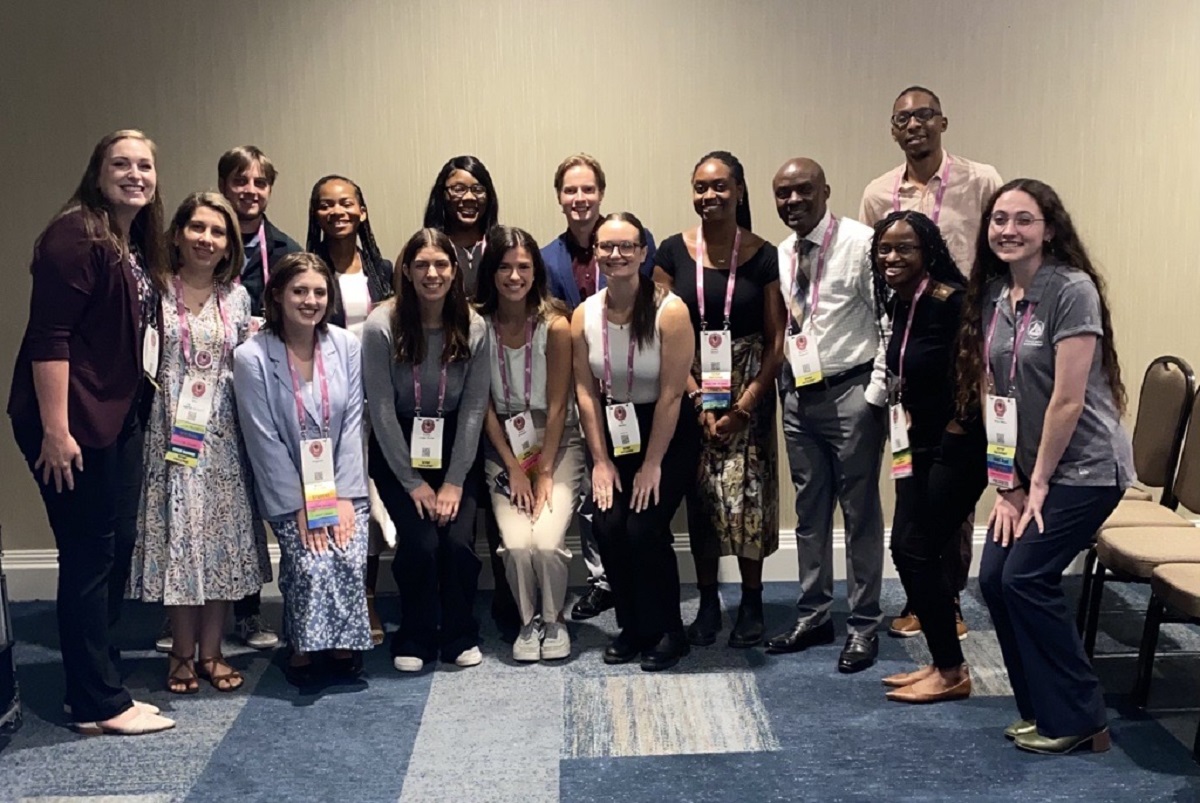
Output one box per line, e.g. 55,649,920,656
858,150,1003,275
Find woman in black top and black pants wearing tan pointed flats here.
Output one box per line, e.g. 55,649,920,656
871,211,988,702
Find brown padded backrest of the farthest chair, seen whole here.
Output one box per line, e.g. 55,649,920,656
1133,356,1200,509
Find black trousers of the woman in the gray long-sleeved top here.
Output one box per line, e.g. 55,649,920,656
367,413,484,661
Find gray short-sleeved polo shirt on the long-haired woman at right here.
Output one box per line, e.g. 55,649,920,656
983,263,1134,489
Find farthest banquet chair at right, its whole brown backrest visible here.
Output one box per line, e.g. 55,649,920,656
1078,356,1200,643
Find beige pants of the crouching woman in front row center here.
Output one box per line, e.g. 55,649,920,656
484,429,583,624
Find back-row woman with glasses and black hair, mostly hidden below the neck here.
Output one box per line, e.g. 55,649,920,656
425,156,499,298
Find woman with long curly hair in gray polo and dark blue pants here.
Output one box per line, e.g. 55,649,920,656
958,179,1133,754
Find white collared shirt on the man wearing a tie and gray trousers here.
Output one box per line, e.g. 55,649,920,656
779,211,887,407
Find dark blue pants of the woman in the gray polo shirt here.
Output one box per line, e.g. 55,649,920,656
979,485,1121,738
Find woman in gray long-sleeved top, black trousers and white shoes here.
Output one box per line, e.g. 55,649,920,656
362,228,491,672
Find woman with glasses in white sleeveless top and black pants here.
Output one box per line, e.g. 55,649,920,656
571,212,700,671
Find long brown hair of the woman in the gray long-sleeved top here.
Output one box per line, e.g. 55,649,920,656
391,228,470,365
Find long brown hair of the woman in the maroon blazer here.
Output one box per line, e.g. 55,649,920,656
52,128,167,290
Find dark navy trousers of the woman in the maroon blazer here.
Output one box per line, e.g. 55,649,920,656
13,407,142,721
